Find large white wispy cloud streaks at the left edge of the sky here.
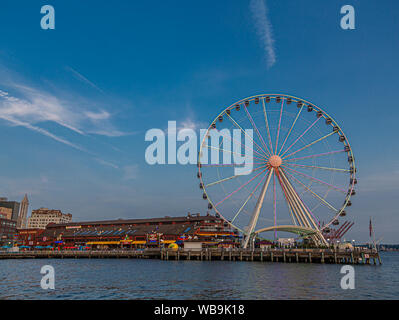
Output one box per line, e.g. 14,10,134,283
0,77,129,169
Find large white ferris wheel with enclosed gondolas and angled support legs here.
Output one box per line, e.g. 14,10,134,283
197,94,357,248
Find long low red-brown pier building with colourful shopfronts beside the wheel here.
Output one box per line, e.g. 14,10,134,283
19,214,239,249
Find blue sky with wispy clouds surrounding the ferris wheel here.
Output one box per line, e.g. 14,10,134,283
0,0,399,243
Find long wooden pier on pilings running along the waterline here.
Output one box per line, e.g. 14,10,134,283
0,248,382,265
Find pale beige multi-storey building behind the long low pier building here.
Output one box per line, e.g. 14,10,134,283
28,208,72,229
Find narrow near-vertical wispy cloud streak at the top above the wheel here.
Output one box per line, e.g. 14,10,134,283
249,0,276,68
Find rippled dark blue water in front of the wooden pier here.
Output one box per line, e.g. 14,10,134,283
0,252,399,300
